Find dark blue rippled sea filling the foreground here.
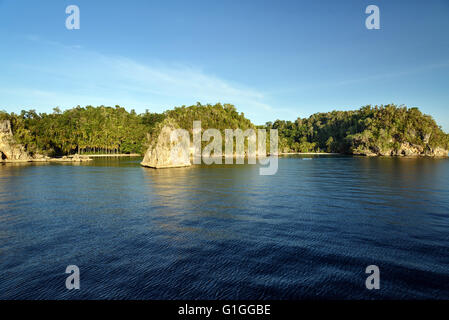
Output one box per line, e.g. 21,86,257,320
0,156,449,299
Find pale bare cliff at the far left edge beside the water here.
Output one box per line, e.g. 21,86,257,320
0,120,31,161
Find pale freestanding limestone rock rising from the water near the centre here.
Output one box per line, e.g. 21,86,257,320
141,119,191,169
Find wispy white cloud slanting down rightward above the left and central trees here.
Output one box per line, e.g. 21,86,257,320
3,35,272,119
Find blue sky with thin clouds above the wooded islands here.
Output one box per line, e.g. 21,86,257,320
0,0,449,132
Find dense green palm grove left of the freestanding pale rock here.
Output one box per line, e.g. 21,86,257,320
0,106,161,155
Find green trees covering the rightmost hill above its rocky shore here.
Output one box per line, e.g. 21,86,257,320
266,105,449,153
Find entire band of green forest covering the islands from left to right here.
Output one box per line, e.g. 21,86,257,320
0,103,449,156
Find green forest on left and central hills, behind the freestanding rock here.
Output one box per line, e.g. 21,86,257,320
0,103,253,156
